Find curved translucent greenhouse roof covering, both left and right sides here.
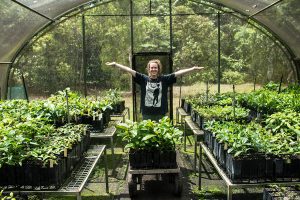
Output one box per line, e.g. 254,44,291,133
0,0,300,96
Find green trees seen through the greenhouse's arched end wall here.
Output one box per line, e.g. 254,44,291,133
10,0,293,95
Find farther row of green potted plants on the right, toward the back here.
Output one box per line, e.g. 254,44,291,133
181,84,300,118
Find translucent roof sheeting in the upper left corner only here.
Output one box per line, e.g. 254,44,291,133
0,0,94,62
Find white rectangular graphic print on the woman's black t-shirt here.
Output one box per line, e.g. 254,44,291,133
145,81,162,107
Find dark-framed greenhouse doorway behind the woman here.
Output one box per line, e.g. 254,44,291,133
132,52,173,121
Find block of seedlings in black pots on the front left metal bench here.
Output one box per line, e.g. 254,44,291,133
0,123,90,188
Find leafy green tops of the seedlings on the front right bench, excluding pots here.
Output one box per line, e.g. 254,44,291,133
206,121,300,158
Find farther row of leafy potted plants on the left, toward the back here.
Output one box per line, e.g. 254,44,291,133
0,88,125,129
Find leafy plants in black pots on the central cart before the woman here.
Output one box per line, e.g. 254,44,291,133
116,117,182,168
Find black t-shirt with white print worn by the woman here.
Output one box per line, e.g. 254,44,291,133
134,72,176,115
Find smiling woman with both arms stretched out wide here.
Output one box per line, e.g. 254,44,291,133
106,59,204,121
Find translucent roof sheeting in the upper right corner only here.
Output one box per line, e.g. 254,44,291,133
209,0,300,60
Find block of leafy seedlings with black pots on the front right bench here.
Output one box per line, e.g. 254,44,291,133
204,110,300,182
